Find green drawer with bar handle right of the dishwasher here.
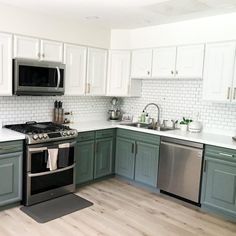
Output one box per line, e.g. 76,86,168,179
205,145,236,163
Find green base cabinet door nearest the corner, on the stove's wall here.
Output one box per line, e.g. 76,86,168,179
94,138,114,179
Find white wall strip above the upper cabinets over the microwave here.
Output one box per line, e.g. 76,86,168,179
0,4,110,48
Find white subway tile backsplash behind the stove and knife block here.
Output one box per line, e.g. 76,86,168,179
0,96,110,125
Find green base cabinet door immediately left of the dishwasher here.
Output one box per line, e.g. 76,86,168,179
135,142,159,187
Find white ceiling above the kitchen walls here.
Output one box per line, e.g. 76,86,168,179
0,0,236,29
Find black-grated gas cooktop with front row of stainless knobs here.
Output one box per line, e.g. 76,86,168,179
5,121,78,144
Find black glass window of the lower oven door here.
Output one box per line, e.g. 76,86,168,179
30,168,74,195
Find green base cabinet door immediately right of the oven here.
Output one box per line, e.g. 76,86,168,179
76,140,94,184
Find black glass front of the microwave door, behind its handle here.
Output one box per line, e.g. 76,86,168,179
19,65,64,88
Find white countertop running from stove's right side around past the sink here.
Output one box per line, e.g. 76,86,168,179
70,121,236,150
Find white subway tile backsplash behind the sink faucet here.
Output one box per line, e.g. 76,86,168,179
122,80,236,134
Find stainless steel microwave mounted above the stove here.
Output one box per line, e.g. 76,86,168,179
13,59,65,96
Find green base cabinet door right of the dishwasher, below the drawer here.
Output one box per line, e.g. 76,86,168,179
202,158,236,217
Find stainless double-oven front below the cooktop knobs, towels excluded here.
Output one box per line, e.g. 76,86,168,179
25,141,76,205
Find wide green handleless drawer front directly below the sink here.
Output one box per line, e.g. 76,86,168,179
117,129,160,145
